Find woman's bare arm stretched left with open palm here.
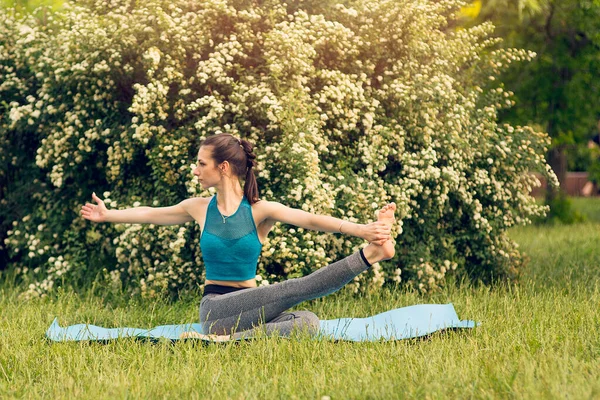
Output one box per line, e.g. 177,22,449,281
81,193,194,225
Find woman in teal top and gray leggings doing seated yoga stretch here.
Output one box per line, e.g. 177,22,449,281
81,134,396,341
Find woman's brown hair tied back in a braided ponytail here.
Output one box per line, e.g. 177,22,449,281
200,133,260,204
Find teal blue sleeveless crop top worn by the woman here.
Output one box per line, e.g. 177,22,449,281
200,195,262,281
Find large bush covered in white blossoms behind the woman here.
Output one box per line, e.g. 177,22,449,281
0,0,555,296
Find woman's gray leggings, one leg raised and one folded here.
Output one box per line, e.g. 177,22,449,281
200,252,369,339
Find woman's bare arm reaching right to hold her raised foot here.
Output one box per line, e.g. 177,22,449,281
266,201,391,244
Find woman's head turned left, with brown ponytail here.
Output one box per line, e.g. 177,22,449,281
194,133,259,204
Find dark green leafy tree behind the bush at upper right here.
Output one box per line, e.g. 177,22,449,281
471,0,600,201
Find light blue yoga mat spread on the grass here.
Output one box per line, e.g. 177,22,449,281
46,303,478,342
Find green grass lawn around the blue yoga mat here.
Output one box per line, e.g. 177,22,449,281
0,200,600,399
